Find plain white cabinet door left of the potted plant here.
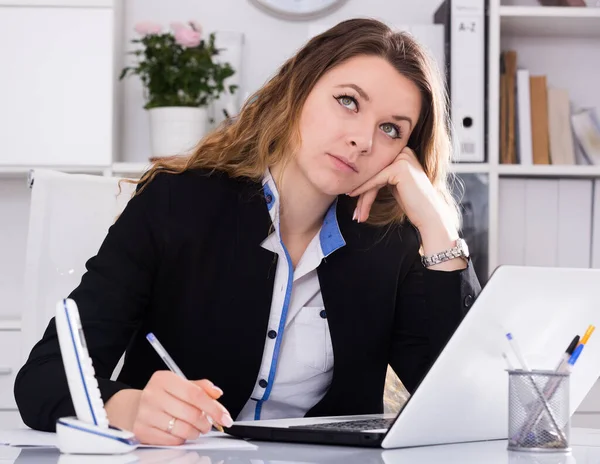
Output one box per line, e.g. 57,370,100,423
0,3,115,166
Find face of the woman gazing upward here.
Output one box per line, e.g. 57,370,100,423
293,56,421,195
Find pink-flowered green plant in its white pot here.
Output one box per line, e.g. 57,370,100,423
119,21,237,157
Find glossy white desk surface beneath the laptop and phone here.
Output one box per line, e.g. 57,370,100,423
0,429,600,464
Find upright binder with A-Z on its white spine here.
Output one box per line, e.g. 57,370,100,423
433,0,487,162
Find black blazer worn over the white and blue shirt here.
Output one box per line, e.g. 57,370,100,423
14,171,480,431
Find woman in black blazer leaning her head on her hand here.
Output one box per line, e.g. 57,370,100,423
15,19,480,445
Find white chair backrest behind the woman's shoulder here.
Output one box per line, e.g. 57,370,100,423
21,169,135,361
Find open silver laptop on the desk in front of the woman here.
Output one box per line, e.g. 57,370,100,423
226,266,600,448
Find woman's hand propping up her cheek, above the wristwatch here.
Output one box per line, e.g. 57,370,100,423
349,147,458,240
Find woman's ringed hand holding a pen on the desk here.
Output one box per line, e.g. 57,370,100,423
106,371,233,446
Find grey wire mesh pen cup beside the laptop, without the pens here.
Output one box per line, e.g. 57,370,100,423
508,370,571,452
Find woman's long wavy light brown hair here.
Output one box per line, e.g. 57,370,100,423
127,19,459,230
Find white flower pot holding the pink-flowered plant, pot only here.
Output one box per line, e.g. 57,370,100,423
148,106,208,157
